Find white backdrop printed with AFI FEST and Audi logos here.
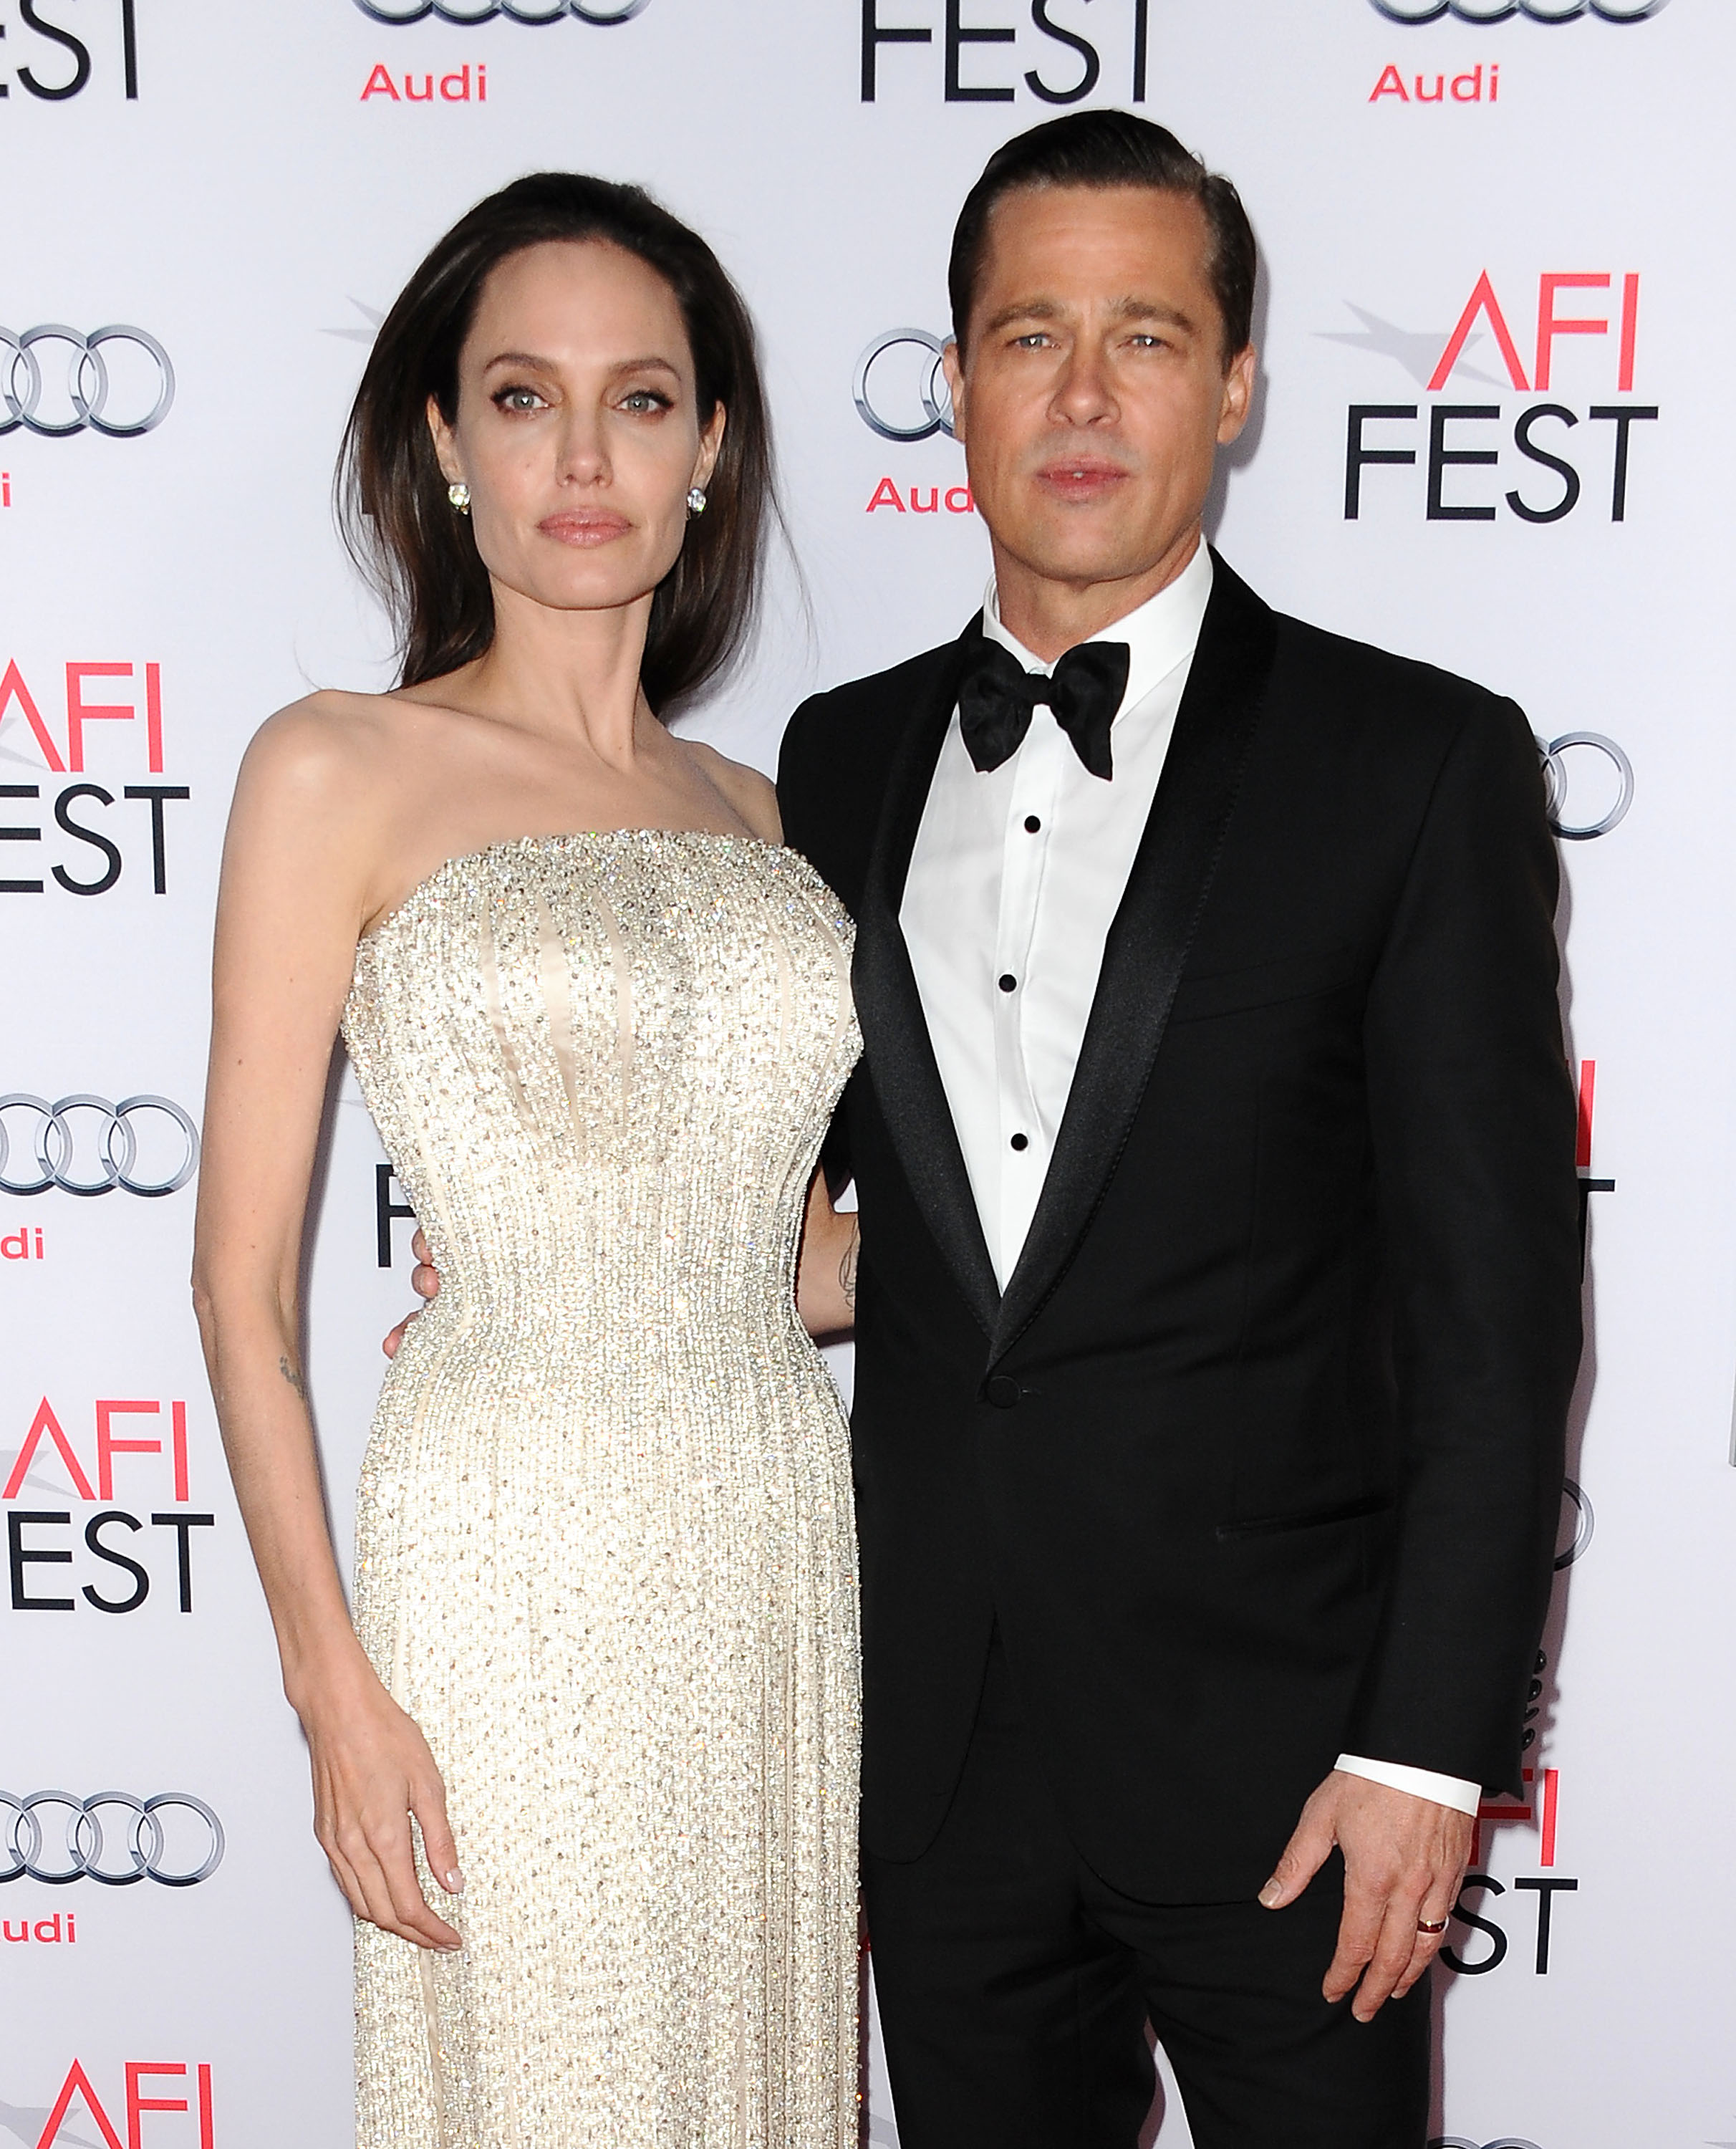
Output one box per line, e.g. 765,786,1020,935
0,0,1736,2149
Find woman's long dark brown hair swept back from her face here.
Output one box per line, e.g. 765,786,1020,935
337,172,776,711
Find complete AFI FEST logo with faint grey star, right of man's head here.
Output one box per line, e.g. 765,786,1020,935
1326,269,1659,527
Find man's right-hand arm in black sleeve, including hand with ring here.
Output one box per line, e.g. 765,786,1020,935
1261,703,1579,2020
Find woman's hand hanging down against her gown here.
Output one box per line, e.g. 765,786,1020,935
299,1663,464,1953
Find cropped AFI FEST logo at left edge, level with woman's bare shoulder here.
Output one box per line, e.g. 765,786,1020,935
0,653,193,890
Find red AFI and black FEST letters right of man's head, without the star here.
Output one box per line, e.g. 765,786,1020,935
1345,269,1659,524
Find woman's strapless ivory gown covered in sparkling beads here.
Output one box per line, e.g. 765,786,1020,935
344,830,859,2149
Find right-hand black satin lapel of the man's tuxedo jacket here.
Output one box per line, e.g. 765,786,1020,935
990,554,1276,1358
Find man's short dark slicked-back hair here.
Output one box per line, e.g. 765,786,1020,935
947,112,1257,365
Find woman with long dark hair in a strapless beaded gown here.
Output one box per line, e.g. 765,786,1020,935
196,174,857,2149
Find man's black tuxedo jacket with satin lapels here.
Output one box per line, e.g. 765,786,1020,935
778,561,1579,1902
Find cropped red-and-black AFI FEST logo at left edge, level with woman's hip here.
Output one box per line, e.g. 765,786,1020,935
0,1397,217,1616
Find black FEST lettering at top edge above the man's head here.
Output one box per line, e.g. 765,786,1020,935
862,0,1152,105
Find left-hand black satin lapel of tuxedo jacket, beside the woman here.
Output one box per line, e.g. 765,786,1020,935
851,621,1001,1335
